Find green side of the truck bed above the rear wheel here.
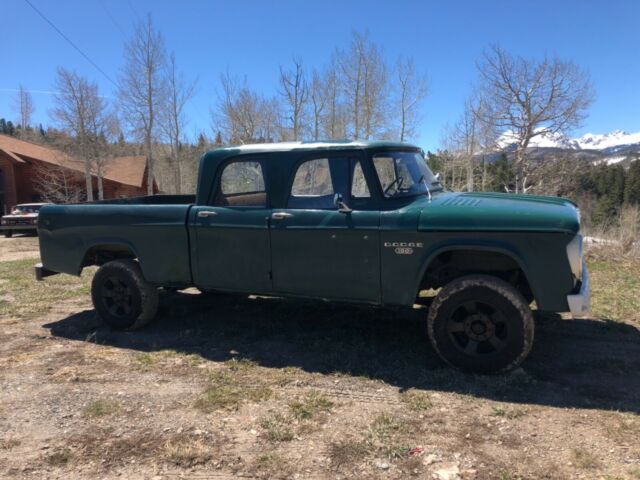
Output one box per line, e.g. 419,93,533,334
38,195,195,286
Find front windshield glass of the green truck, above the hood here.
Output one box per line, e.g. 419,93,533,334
373,152,442,198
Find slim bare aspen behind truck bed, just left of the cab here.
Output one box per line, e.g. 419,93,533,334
159,53,195,194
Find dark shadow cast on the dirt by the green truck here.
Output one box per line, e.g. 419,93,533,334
44,292,640,413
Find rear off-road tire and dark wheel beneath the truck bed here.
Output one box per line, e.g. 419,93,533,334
91,259,159,330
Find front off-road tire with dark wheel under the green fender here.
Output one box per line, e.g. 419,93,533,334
427,275,534,373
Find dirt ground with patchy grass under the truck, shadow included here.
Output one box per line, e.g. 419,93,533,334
0,238,640,480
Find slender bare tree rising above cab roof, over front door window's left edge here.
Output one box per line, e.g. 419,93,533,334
280,57,309,141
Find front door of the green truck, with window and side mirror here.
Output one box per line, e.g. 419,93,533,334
271,156,380,303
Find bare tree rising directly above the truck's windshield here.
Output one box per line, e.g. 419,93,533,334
396,58,427,142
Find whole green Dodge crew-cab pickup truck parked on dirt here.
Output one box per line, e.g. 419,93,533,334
36,142,589,372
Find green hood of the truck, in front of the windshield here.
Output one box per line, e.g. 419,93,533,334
418,192,580,234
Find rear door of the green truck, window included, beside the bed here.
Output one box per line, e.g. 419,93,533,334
189,157,271,293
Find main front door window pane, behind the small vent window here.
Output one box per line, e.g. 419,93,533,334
287,158,334,208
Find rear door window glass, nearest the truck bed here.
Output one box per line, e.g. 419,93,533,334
214,161,267,207
